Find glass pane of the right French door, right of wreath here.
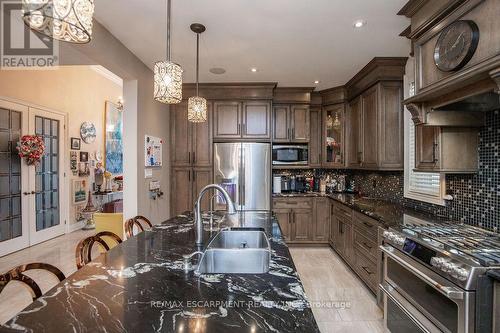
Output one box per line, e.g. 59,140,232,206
35,116,60,231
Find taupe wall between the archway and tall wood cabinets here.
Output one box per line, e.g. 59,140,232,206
60,20,170,223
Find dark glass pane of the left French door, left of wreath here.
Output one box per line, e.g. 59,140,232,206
0,108,23,242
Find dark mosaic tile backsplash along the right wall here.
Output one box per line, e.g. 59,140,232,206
278,111,500,232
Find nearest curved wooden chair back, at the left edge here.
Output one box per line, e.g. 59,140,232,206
0,263,66,300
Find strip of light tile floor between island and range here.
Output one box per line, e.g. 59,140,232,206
290,247,384,333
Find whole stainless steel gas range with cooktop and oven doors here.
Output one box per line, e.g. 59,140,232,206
380,222,500,333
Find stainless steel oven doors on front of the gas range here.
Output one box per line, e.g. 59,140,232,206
380,243,475,333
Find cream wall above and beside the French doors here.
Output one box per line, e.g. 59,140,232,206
0,66,123,224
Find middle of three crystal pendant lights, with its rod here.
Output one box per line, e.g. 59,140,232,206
154,0,182,104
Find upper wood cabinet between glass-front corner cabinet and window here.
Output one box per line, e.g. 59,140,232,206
346,81,404,170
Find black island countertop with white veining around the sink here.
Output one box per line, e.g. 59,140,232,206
0,213,319,333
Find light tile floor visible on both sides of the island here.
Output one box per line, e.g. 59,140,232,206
0,231,384,333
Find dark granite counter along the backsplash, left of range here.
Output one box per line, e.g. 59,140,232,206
273,192,445,228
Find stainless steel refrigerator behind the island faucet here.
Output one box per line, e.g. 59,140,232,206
214,142,271,211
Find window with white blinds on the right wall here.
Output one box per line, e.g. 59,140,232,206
405,111,444,205
